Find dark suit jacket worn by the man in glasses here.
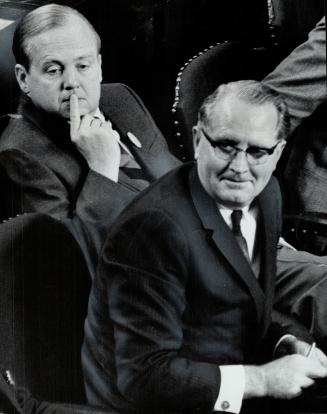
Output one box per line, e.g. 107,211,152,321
82,165,308,413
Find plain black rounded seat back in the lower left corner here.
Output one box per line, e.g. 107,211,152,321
0,213,90,403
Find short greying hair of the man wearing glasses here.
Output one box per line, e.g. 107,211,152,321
198,80,289,139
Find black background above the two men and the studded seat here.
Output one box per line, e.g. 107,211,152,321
0,0,324,154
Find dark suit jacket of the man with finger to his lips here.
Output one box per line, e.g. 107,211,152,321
0,84,177,258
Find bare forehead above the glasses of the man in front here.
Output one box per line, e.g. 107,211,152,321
208,97,278,145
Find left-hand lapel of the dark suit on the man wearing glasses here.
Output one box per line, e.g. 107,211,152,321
189,167,265,320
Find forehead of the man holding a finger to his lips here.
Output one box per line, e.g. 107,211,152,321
26,17,98,62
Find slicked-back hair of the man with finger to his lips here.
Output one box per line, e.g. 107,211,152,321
12,3,101,70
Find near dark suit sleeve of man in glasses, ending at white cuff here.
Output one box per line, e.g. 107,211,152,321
98,211,220,412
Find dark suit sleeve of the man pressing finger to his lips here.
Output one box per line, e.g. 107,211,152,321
0,149,137,258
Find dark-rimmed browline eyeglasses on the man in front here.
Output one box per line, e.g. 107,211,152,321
201,128,279,165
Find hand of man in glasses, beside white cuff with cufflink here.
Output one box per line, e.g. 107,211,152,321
244,354,327,399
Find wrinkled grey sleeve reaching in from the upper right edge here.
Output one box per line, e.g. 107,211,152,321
263,18,326,130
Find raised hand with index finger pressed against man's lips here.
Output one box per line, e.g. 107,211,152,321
70,94,120,182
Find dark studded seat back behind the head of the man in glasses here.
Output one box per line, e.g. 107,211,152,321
172,42,280,161
